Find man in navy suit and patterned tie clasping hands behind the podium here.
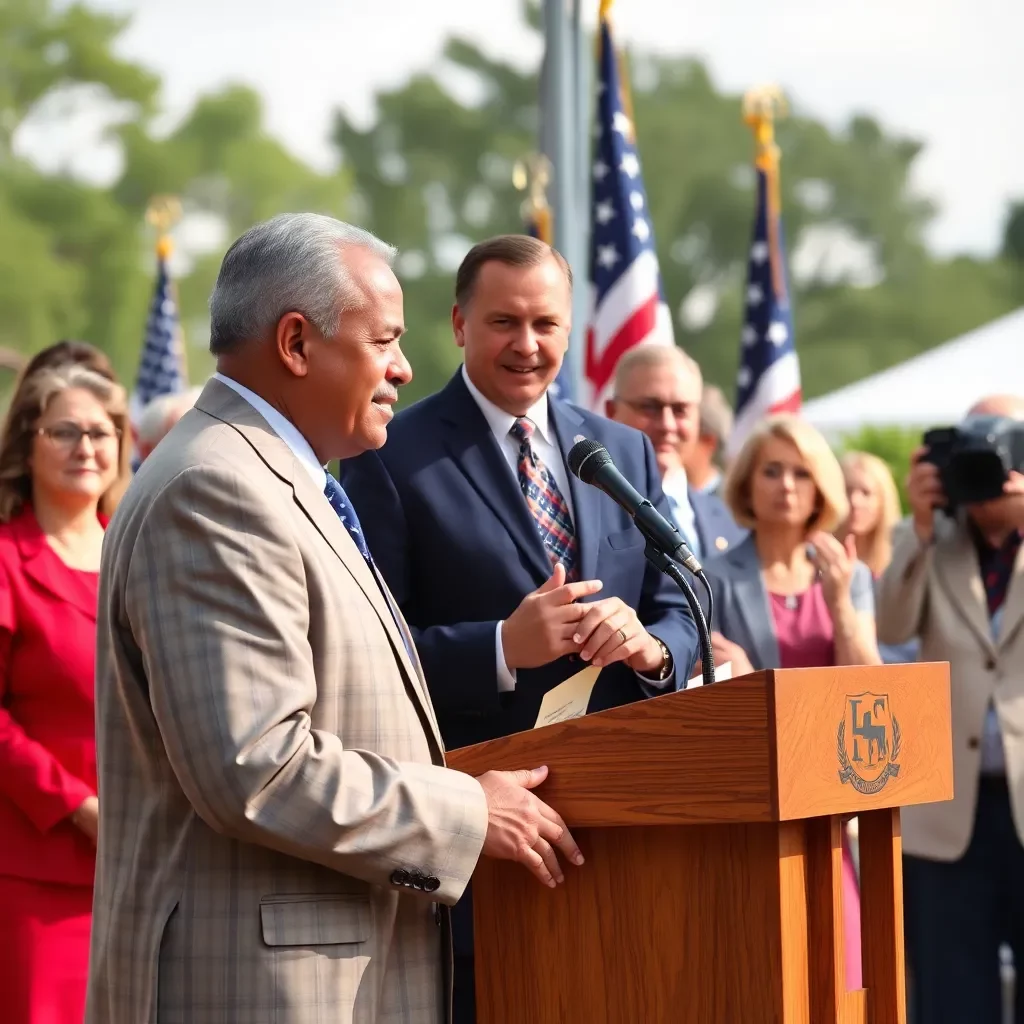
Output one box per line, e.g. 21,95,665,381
342,236,697,1022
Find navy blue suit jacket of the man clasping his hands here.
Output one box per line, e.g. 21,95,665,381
341,370,697,749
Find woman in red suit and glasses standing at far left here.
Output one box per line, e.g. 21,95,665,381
0,364,125,1024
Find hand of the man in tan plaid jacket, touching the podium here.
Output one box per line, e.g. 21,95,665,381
477,767,583,889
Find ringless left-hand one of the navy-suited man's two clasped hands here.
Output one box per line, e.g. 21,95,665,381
502,562,602,671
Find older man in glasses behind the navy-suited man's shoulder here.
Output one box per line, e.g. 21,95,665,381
605,345,746,561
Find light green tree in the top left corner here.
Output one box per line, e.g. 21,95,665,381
0,0,158,376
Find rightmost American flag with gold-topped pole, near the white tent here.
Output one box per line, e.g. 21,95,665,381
728,164,801,455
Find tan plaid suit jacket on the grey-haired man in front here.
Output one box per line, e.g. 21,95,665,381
87,381,487,1024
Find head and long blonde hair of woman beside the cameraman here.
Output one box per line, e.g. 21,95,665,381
838,452,902,580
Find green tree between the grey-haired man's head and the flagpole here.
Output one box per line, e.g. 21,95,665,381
334,39,537,397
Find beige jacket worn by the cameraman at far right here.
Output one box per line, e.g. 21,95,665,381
877,516,1024,860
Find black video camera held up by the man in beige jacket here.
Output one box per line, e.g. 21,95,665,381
924,416,1024,512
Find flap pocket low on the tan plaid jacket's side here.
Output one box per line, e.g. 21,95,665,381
259,893,372,946
